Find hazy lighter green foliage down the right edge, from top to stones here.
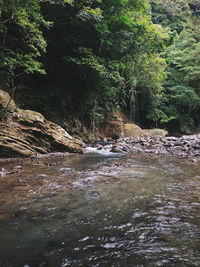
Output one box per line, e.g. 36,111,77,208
152,0,200,133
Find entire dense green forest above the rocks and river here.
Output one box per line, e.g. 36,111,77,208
0,0,200,134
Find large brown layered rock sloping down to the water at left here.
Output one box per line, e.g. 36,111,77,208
0,90,82,157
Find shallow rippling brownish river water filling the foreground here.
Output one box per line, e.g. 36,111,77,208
0,151,200,267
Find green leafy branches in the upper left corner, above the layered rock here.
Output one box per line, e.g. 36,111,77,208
0,0,47,87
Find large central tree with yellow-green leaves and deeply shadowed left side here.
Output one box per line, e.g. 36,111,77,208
36,0,169,131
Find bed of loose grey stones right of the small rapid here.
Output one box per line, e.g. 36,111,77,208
94,135,200,158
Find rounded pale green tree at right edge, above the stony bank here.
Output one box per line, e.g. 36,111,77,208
157,30,200,132
